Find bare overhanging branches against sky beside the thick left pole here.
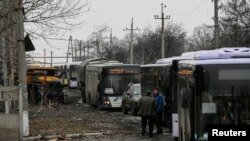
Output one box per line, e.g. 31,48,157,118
23,0,89,38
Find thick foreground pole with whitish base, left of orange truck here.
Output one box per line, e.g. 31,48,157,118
15,0,29,140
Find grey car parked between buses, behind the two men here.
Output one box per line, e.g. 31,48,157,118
122,83,141,115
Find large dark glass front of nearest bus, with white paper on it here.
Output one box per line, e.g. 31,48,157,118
197,65,250,140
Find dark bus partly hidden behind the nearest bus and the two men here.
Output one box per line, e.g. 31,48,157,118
141,56,190,131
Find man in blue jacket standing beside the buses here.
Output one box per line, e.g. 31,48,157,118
153,88,164,134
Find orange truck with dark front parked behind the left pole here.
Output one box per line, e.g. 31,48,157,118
27,64,64,104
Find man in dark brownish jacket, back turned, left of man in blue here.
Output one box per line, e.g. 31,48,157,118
138,91,155,137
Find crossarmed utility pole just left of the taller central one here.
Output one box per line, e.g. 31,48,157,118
124,18,139,64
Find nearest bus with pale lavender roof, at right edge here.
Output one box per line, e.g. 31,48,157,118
177,47,250,141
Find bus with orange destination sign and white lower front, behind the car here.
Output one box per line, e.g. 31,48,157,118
80,59,140,109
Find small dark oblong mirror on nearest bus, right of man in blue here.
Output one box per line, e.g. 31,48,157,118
181,88,191,108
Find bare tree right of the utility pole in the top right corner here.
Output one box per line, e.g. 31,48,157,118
220,0,250,47
